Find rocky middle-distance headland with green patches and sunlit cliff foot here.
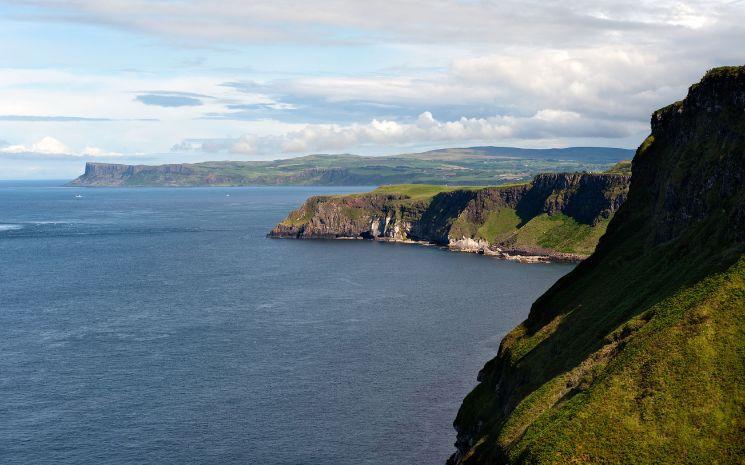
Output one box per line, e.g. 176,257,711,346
269,173,629,260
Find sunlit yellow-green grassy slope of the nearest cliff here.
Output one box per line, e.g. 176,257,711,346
501,259,745,464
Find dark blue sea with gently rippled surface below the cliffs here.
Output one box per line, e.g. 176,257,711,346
0,182,571,465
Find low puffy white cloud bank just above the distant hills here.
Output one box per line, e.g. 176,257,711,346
173,109,639,155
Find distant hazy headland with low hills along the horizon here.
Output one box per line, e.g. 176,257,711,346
70,147,632,186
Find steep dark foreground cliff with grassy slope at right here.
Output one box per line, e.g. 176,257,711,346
450,67,745,464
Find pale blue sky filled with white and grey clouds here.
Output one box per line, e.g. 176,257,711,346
0,0,745,179
